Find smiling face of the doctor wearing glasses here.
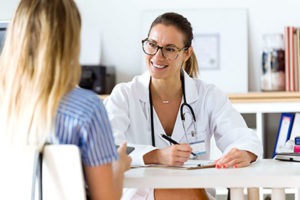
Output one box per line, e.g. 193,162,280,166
145,24,191,79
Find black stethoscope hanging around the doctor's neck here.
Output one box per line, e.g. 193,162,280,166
149,71,196,147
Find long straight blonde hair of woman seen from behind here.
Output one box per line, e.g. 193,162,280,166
0,0,81,145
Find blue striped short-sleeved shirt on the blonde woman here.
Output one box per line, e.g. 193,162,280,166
51,88,118,166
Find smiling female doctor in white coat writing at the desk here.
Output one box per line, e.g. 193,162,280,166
104,13,262,199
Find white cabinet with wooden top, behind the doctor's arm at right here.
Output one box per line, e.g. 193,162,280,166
229,92,300,158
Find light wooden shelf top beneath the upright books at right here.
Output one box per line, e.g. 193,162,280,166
228,92,300,103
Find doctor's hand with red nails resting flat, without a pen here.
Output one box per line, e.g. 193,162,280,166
216,148,257,168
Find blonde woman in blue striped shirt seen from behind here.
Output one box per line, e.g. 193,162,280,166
0,0,131,200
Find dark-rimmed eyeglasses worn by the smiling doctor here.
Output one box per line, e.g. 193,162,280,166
142,38,189,60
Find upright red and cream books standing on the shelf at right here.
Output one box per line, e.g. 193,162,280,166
284,26,300,91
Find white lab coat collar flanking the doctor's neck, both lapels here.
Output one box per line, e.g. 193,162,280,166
137,71,199,104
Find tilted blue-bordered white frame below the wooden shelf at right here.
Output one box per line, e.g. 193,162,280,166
273,113,295,157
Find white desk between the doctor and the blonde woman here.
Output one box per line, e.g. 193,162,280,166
124,159,300,200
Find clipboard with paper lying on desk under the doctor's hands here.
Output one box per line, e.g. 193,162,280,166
131,160,215,170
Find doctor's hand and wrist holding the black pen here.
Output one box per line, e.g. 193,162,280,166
144,144,192,166
